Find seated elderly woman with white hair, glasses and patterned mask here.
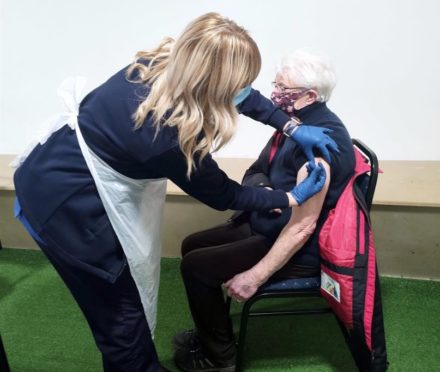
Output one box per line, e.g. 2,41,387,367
173,51,355,371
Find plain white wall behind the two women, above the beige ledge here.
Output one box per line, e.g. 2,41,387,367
0,0,440,160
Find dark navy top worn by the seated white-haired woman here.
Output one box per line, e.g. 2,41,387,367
237,102,355,267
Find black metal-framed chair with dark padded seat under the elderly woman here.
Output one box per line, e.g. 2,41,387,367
227,139,379,372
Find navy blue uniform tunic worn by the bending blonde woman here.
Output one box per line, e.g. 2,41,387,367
14,61,296,281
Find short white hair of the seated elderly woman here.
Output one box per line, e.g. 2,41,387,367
277,50,336,102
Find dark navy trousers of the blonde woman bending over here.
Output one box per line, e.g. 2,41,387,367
35,244,163,372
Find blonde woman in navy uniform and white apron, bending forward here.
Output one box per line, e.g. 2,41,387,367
14,13,337,372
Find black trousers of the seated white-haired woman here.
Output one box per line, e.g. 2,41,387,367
181,221,317,361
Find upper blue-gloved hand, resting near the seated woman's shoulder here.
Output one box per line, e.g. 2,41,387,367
291,124,339,167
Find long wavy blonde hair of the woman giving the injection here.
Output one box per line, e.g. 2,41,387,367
127,13,261,177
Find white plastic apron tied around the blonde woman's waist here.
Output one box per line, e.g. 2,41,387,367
12,78,166,334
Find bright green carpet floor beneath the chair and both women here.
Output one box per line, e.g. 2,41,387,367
0,249,440,372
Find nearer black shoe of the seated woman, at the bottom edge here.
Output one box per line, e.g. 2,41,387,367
174,349,235,372
